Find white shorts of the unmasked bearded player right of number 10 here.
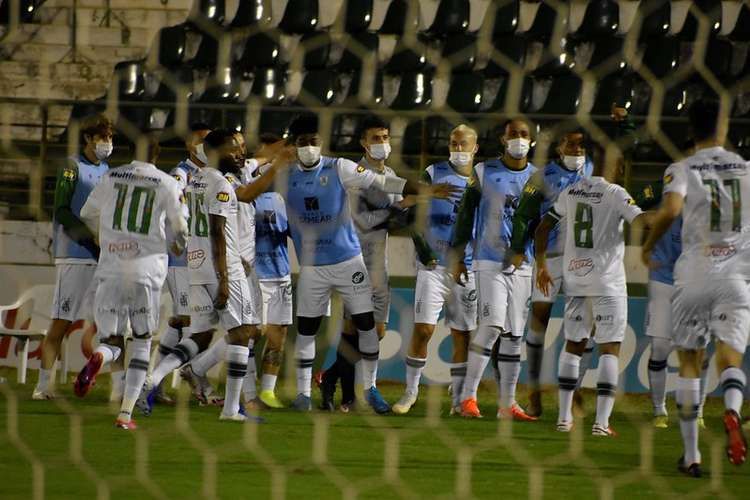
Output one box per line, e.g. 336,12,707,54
190,279,260,333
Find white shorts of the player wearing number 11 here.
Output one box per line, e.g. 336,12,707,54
672,279,750,353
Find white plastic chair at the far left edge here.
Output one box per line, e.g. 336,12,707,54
0,287,49,384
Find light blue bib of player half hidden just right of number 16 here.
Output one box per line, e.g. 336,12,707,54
255,192,289,280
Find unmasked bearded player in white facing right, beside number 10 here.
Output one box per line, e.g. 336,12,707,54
139,130,283,421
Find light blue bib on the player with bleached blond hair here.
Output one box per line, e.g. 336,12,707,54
424,161,473,268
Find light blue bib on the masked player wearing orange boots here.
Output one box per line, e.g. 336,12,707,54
474,159,536,270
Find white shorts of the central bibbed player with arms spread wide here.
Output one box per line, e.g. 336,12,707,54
297,255,372,318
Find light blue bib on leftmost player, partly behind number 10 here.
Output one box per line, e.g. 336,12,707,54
53,154,109,262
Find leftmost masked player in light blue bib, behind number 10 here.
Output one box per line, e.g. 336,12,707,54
32,115,114,400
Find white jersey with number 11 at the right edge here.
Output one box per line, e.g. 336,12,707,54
664,147,750,282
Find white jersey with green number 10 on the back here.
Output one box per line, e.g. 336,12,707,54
81,161,187,287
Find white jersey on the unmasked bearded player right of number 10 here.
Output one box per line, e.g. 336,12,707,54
185,168,245,285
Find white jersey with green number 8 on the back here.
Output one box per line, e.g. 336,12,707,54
547,177,642,297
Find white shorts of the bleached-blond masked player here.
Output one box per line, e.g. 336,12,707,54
414,267,477,332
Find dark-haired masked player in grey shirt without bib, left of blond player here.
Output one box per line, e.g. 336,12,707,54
320,116,414,412
